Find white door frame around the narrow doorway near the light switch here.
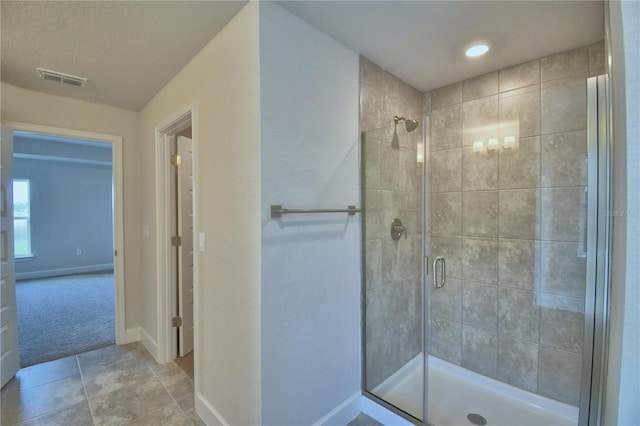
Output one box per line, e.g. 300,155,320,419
155,100,199,368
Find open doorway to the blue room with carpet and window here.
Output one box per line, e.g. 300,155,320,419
2,123,124,367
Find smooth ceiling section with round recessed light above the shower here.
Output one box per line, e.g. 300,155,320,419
278,0,604,91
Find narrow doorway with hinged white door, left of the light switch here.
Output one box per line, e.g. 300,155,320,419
156,104,198,386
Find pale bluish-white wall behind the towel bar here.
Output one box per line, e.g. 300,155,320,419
260,2,362,425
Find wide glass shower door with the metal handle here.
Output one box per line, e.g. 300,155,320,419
425,78,597,426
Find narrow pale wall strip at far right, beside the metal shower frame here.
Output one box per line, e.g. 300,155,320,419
604,1,640,426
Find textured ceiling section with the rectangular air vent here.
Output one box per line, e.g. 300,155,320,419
0,0,246,111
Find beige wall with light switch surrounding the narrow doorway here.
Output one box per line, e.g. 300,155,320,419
139,2,261,425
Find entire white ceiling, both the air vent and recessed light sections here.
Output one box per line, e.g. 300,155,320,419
0,0,604,110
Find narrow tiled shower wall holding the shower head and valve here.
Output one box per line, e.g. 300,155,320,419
360,57,423,390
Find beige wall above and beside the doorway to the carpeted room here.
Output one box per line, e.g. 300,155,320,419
0,83,144,329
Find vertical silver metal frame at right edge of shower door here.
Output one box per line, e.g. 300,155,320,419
578,75,611,426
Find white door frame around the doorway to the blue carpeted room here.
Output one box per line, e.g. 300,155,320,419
2,121,127,345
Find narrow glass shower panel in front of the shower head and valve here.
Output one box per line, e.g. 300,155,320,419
361,122,424,421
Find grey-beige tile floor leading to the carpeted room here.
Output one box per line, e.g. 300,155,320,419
0,342,204,426
